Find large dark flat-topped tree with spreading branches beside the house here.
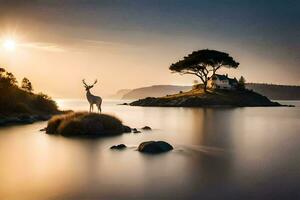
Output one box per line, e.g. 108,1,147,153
169,49,239,92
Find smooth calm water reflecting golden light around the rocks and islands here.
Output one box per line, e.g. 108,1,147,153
0,100,300,200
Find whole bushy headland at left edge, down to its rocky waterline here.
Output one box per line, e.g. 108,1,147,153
0,68,62,126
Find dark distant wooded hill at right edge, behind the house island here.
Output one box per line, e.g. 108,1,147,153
246,83,300,100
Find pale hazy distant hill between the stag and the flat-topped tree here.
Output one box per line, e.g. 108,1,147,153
122,85,192,99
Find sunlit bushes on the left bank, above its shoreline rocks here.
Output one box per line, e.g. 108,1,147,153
0,68,58,115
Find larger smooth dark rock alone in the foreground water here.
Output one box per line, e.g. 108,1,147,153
138,141,173,154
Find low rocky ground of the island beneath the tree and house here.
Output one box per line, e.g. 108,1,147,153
130,89,281,107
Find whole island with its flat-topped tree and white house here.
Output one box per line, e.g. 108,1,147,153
129,49,281,107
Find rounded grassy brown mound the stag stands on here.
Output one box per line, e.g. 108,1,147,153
47,112,123,137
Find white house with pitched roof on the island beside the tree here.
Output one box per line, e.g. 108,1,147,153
207,74,238,90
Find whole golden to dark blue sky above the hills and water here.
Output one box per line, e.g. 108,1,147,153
0,0,300,98
